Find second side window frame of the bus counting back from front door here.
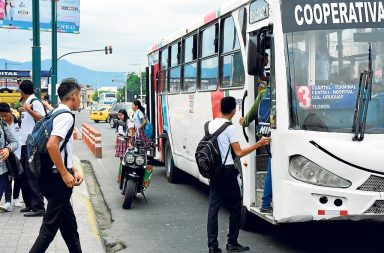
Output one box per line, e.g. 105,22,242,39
196,22,221,92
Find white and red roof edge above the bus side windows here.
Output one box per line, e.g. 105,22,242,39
147,0,249,54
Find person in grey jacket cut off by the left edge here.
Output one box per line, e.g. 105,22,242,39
0,111,19,211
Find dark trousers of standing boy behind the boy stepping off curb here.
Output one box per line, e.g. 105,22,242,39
20,145,44,211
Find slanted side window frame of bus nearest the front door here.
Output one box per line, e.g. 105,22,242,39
218,13,246,91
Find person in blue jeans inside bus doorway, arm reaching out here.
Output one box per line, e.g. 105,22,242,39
239,81,273,213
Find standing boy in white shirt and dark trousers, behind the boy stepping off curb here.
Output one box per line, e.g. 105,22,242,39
19,80,46,217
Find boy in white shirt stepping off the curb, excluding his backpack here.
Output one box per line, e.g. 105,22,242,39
30,78,83,253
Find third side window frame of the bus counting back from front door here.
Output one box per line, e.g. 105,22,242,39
180,31,200,94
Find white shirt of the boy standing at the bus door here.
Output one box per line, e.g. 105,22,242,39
208,118,239,165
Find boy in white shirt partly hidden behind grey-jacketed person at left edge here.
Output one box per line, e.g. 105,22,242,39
0,103,22,212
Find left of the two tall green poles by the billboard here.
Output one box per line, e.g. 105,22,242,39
32,0,41,98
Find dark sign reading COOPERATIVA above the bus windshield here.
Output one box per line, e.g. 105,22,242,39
281,0,384,33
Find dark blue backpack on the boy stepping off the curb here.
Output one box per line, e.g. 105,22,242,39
26,109,75,177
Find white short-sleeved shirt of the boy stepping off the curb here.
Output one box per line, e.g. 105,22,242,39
51,104,74,169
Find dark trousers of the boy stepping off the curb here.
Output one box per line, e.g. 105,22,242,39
30,173,82,253
